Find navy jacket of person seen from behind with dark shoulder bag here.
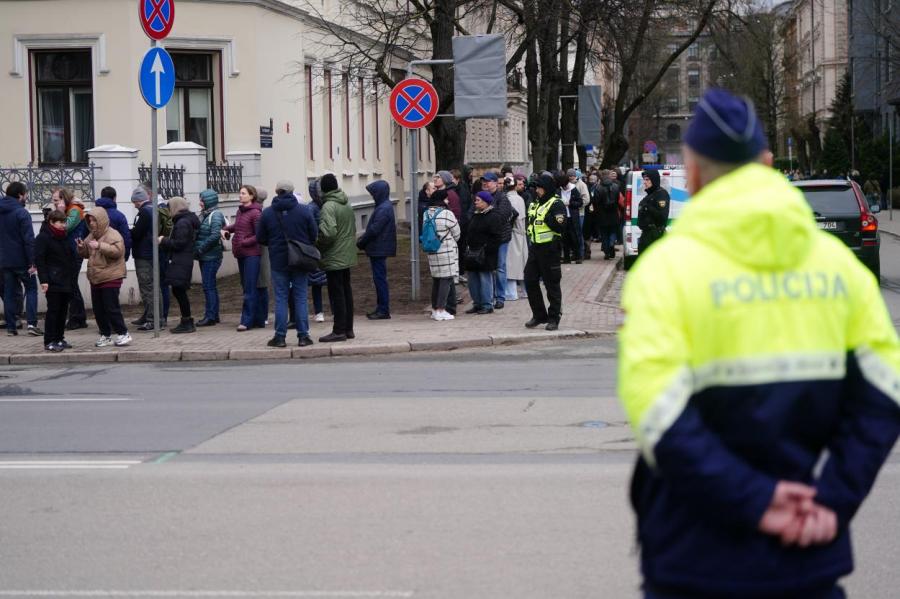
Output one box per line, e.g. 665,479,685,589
256,192,318,272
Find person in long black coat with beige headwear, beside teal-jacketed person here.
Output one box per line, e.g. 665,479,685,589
159,197,200,334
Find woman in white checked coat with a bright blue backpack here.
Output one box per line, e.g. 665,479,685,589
422,189,460,320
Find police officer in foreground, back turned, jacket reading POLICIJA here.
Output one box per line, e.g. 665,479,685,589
619,90,900,599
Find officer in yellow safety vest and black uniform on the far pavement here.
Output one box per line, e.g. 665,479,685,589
525,175,566,331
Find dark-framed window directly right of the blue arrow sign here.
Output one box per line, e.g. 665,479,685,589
166,51,216,162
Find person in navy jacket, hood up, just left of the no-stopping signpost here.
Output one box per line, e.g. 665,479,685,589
356,179,397,320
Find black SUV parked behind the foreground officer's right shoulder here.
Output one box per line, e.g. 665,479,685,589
794,179,881,281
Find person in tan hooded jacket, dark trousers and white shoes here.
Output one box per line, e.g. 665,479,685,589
75,206,131,347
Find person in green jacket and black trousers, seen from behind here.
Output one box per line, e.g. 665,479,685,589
318,173,357,343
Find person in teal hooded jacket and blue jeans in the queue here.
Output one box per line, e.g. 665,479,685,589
194,189,226,327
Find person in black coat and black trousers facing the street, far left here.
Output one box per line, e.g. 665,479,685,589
34,210,75,352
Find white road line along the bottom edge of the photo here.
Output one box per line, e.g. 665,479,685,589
0,590,413,599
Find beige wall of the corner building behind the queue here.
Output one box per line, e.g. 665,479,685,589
0,0,434,209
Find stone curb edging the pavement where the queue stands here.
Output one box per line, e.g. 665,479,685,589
0,329,616,366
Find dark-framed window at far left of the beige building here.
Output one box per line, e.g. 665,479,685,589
31,49,94,164
